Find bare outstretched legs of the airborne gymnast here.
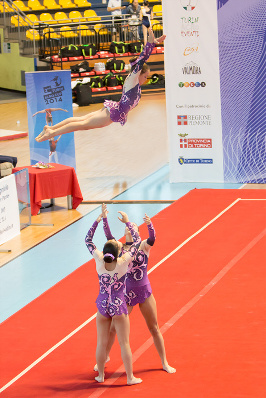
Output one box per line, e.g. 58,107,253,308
35,108,112,142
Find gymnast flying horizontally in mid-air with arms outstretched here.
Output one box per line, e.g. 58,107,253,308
35,29,166,142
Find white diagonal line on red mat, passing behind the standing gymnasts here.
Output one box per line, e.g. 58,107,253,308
0,198,260,393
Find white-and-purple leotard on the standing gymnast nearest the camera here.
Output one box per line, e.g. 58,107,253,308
85,221,141,318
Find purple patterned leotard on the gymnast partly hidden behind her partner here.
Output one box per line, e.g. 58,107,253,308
103,218,155,306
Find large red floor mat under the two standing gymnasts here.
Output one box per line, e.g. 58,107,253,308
0,190,266,398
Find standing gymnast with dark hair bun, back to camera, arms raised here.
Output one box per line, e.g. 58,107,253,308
85,211,142,385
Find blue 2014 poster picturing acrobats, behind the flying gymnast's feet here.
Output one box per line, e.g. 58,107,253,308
25,70,76,168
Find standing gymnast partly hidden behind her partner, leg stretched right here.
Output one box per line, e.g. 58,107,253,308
94,204,176,373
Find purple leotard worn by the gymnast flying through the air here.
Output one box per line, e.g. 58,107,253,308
103,42,155,126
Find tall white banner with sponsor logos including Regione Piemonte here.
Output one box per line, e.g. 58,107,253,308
162,0,224,182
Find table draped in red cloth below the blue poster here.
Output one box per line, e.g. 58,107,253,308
12,163,83,216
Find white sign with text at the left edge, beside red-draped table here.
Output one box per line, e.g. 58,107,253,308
0,175,20,245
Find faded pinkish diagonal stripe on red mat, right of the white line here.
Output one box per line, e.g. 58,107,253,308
88,228,266,398
